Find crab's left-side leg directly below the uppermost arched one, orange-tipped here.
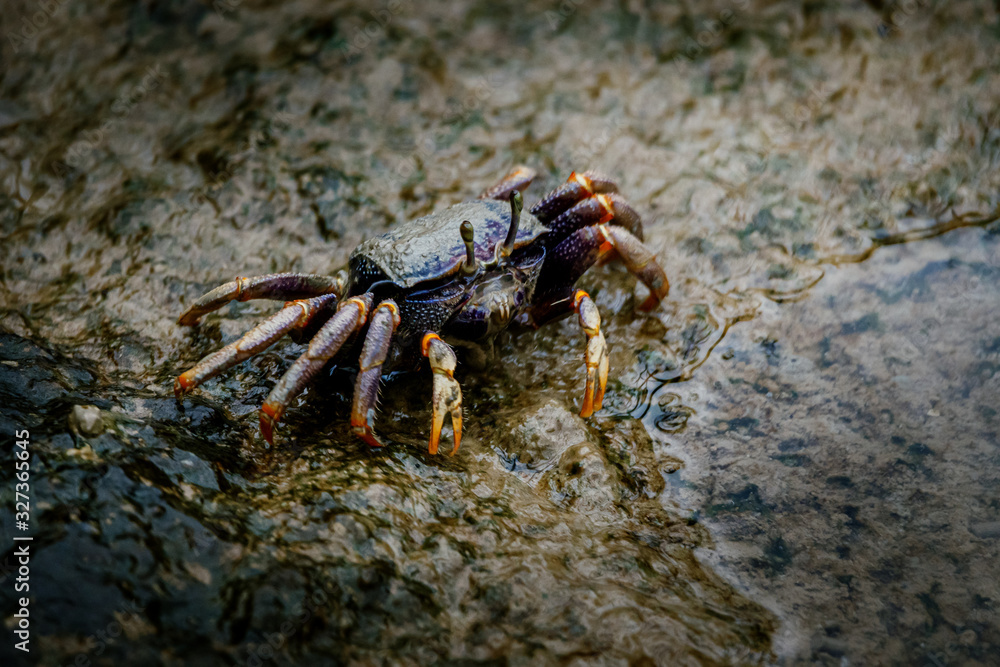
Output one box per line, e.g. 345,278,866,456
174,294,337,399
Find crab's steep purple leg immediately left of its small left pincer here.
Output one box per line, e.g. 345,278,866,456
351,299,400,447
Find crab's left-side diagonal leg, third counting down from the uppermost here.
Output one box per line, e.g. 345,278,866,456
260,294,372,444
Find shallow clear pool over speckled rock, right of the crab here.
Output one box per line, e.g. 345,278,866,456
678,230,1000,665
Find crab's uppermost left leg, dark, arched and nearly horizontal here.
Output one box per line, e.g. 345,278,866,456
177,273,345,326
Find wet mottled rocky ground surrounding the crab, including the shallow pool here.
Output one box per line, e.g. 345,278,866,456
0,0,1000,665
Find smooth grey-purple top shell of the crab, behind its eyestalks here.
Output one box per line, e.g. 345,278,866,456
349,200,548,289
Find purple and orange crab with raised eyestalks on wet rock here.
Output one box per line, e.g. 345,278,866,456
174,167,670,455
